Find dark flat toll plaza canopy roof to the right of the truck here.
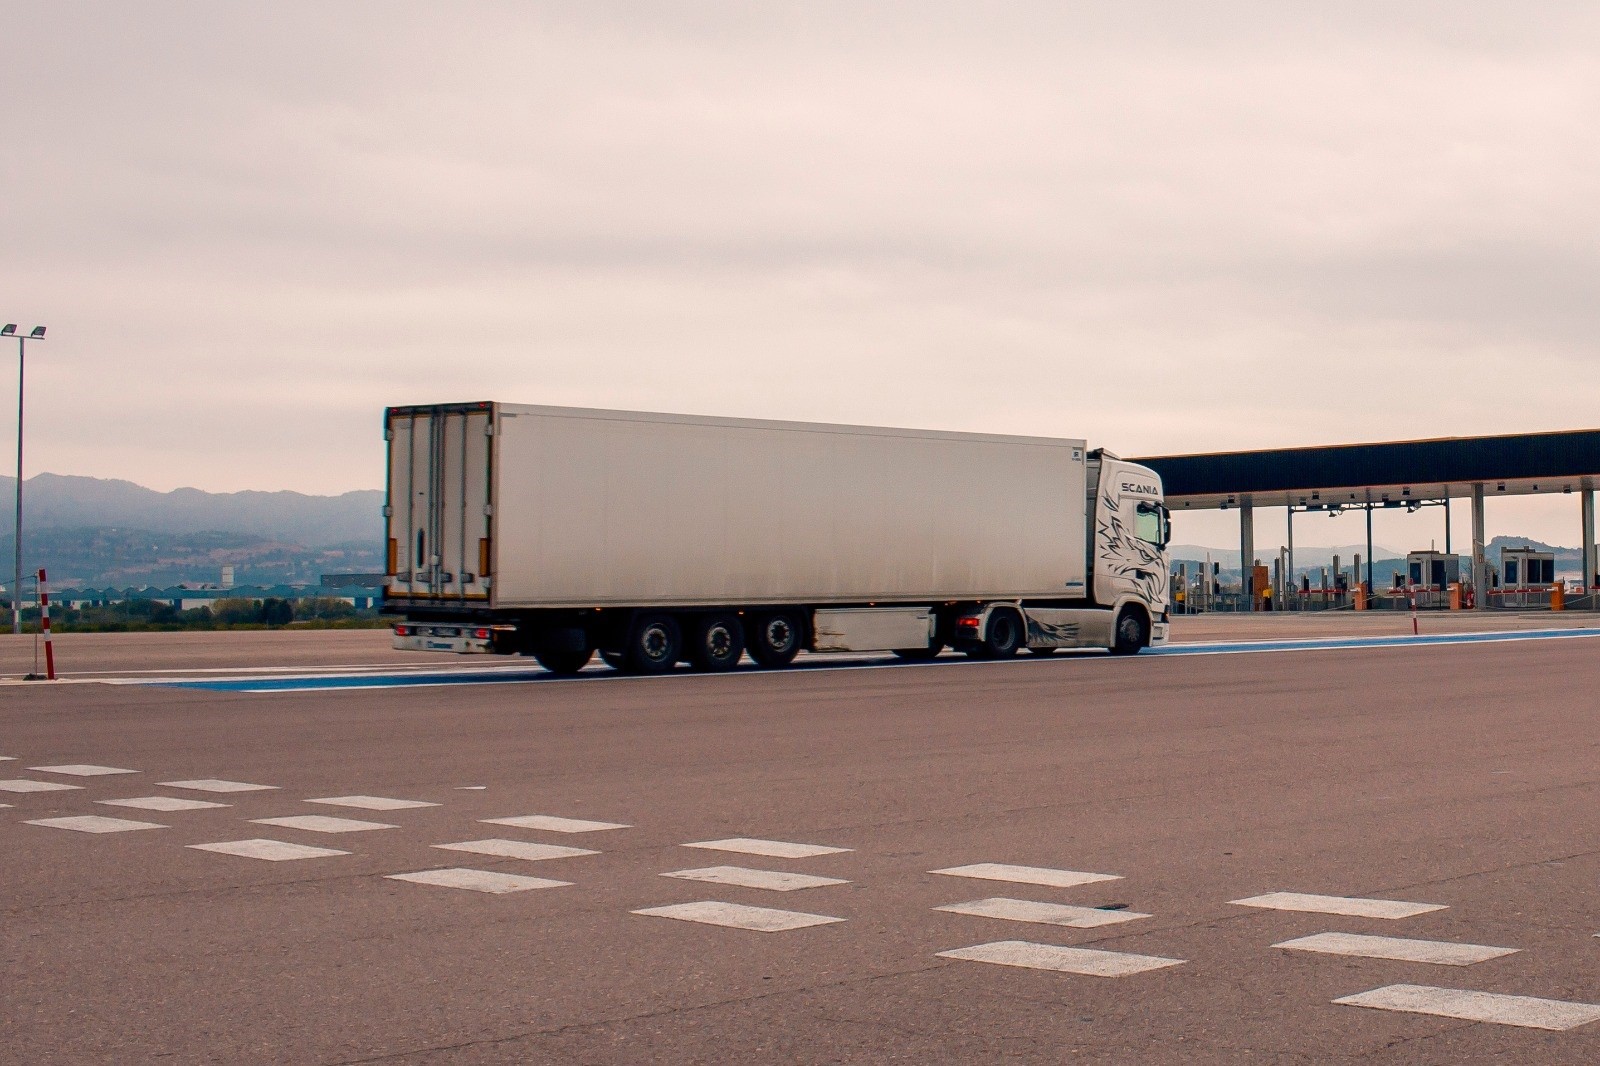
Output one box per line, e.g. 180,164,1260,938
1134,429,1600,511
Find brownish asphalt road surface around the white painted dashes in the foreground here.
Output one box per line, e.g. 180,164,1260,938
0,619,1600,1063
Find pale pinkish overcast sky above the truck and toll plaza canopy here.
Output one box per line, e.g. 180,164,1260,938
0,0,1600,547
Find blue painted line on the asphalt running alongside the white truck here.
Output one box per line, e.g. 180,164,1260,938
154,629,1600,693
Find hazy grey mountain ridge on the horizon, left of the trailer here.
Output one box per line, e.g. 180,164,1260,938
0,474,384,549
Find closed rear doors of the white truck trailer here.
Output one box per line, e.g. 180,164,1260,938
386,403,493,600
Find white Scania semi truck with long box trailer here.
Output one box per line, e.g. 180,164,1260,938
382,403,1171,674
